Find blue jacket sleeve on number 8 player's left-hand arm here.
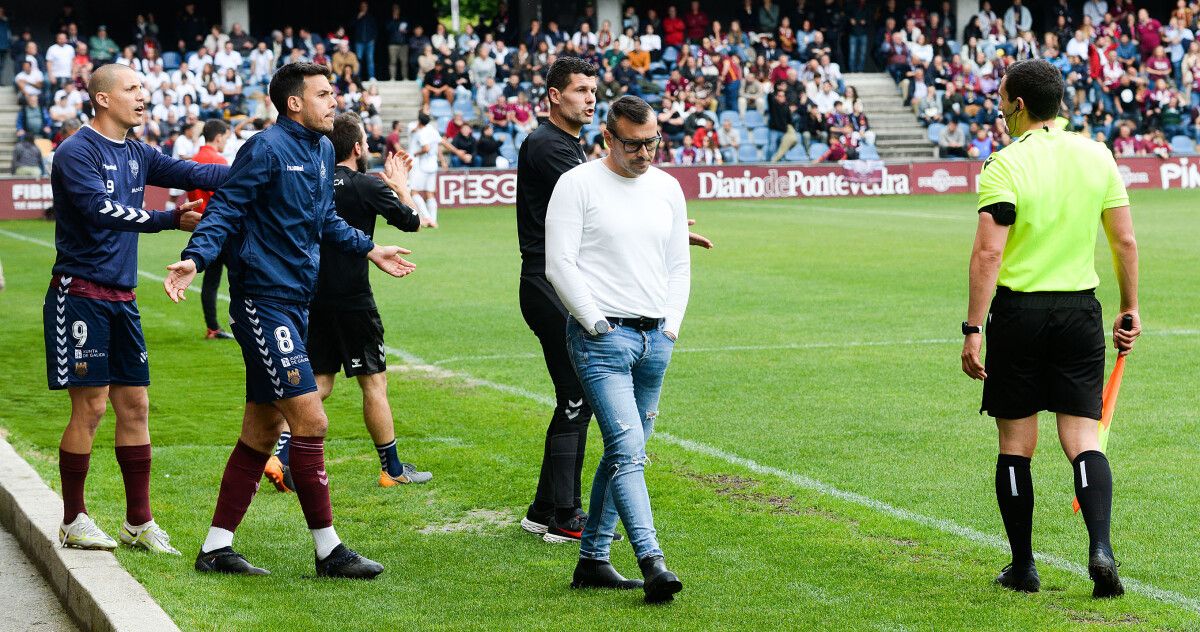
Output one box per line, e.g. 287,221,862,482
180,136,274,272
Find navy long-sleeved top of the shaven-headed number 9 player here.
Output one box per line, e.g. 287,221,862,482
50,126,229,289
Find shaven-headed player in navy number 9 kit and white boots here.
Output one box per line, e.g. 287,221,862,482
42,64,229,555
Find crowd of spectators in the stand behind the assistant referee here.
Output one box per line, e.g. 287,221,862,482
876,0,1200,158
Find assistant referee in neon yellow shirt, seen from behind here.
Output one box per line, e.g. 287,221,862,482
961,60,1141,597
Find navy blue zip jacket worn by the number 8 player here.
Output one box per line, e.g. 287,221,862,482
181,116,374,306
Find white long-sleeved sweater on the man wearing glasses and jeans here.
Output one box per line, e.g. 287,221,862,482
546,159,691,336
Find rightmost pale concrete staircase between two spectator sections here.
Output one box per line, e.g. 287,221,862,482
844,72,935,161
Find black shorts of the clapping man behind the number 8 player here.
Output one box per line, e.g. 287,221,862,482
306,307,388,378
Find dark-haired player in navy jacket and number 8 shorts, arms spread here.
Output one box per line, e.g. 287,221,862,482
163,62,414,579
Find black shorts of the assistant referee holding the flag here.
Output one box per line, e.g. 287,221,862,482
979,288,1105,420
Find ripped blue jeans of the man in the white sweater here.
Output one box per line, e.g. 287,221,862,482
566,318,674,560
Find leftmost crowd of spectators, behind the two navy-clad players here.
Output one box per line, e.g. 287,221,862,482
7,2,396,175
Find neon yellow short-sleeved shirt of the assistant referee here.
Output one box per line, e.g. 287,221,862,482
978,127,1129,291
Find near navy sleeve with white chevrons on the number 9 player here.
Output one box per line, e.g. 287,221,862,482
54,143,179,233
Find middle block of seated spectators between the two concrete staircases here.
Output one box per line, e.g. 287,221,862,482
403,0,877,164
